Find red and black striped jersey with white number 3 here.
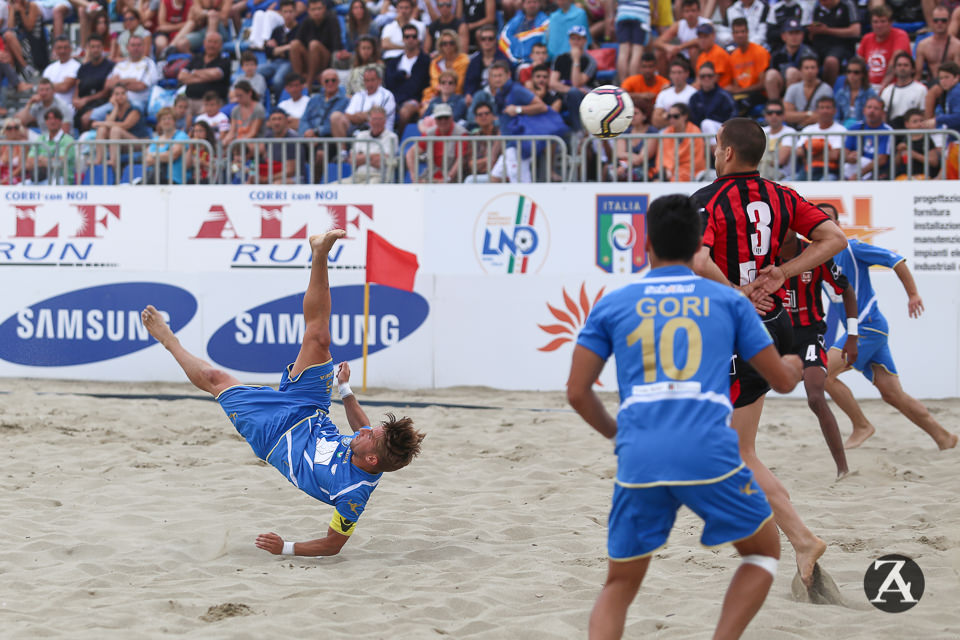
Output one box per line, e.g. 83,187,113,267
693,172,829,286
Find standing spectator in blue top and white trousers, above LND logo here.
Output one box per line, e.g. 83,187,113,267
488,60,548,182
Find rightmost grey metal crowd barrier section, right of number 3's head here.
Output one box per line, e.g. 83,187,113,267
773,129,960,180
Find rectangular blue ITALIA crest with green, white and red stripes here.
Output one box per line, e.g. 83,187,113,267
597,194,650,273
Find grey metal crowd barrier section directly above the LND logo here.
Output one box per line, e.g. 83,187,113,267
400,135,568,183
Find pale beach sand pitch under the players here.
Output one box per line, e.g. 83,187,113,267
0,380,960,640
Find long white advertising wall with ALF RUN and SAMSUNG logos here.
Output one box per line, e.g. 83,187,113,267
0,182,960,397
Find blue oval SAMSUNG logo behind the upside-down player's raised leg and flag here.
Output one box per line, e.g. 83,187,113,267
207,285,430,373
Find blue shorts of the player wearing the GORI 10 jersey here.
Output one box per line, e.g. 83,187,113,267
607,466,773,562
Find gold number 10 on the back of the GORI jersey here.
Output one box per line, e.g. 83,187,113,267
627,317,703,384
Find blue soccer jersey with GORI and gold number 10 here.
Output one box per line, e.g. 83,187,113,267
577,266,773,487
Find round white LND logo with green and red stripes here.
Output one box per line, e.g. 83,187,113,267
474,193,550,274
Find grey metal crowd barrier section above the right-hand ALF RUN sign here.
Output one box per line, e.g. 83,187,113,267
224,138,397,184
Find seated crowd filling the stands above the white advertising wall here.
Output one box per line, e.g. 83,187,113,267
0,0,960,184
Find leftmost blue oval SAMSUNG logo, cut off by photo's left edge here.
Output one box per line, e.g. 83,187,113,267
0,282,197,367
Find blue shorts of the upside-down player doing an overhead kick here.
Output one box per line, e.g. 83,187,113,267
217,360,334,460
